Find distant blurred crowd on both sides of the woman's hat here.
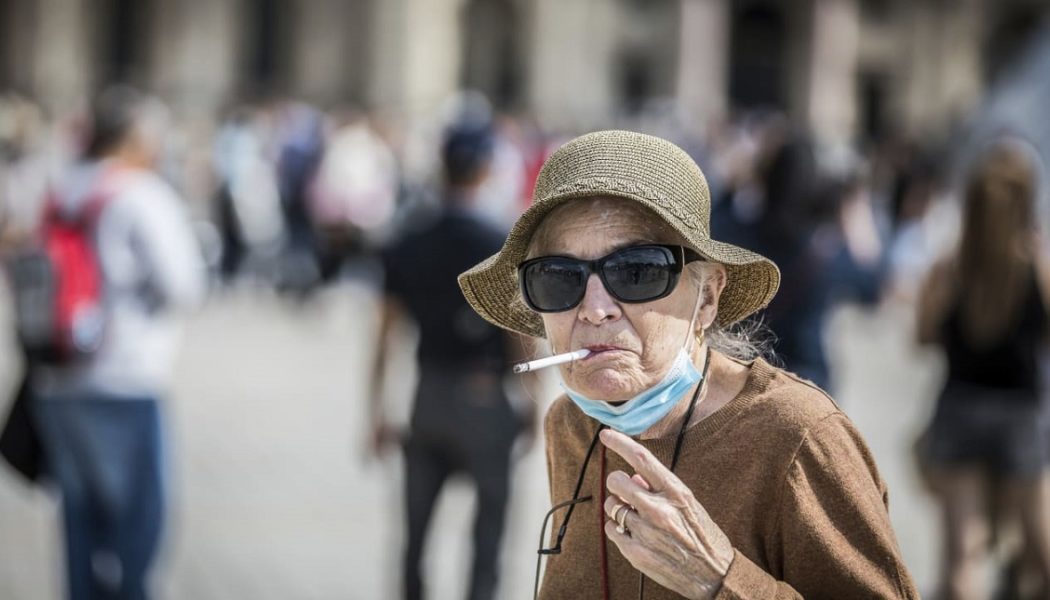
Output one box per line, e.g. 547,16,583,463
0,92,958,304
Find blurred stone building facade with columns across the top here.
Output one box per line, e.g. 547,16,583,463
0,0,1048,141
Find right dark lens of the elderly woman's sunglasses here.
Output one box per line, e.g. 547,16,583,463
602,247,676,303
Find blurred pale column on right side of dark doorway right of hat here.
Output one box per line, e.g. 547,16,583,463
806,0,860,144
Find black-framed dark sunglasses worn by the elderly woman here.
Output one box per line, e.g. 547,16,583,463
518,244,704,312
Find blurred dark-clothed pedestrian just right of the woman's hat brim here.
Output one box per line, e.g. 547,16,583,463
726,135,882,390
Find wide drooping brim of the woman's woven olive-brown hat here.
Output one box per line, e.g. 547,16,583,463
459,189,780,337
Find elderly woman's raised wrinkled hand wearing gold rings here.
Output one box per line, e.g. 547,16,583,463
602,430,733,599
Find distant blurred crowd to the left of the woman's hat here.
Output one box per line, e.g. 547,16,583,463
0,94,567,292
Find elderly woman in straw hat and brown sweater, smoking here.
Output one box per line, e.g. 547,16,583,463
460,131,918,600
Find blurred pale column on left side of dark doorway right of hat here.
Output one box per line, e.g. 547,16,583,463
677,0,731,126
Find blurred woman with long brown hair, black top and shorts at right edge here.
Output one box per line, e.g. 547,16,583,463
918,142,1050,600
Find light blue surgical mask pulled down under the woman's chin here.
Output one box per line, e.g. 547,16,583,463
562,287,702,436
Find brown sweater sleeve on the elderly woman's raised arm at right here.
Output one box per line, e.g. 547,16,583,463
718,413,919,600
